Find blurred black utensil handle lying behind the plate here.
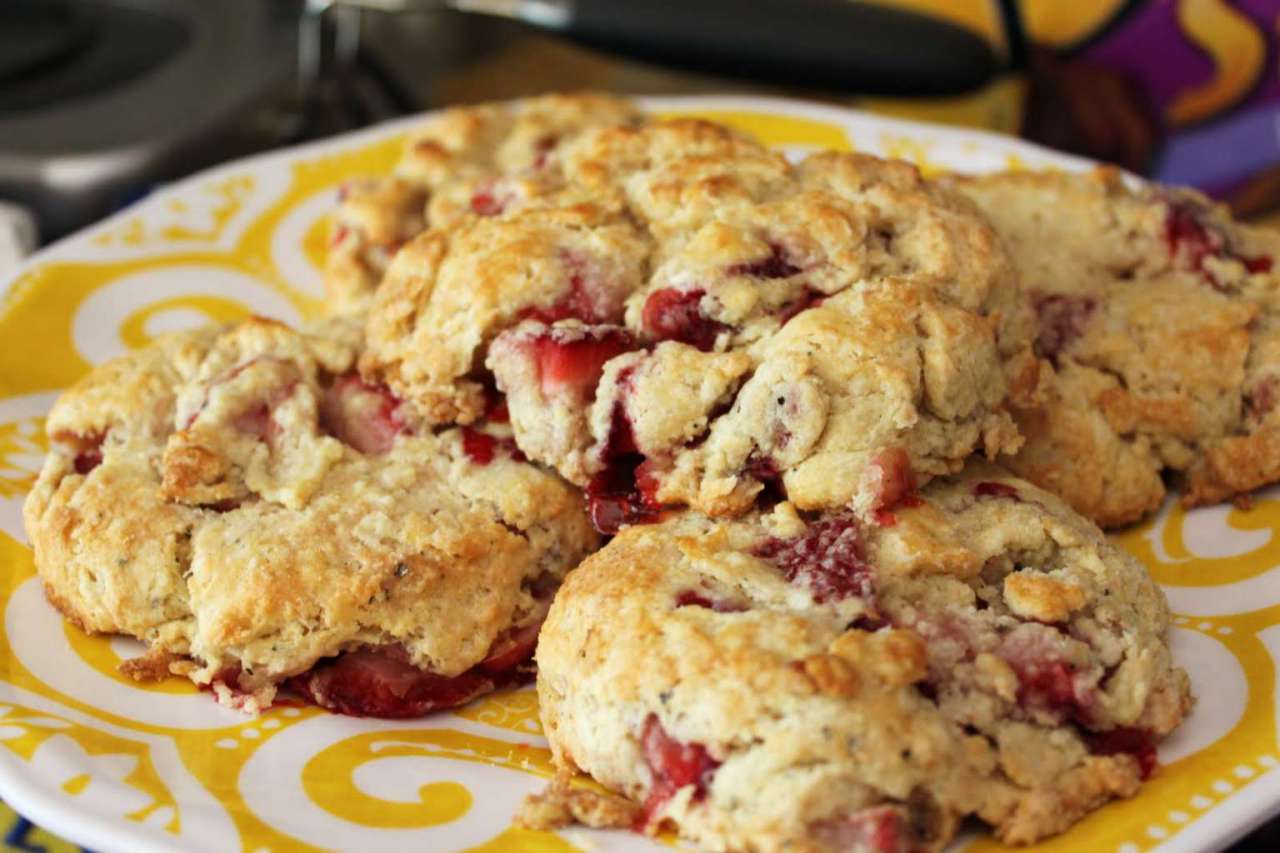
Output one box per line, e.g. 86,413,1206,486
559,0,998,95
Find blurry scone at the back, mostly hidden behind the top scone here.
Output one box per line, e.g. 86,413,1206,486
325,92,640,313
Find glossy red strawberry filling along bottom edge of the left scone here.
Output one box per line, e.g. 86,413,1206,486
288,625,538,719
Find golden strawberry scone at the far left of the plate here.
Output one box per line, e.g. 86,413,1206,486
24,319,596,716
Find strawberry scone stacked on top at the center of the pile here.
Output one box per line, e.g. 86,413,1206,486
361,112,1036,530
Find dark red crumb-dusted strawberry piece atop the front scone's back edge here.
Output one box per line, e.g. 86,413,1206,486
751,515,874,603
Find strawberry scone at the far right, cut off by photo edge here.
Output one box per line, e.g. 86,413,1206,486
950,169,1280,526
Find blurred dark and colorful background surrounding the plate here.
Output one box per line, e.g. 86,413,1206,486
0,0,1280,850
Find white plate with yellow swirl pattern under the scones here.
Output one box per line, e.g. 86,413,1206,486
0,99,1280,853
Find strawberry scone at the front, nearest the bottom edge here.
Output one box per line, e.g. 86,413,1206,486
522,462,1190,852
